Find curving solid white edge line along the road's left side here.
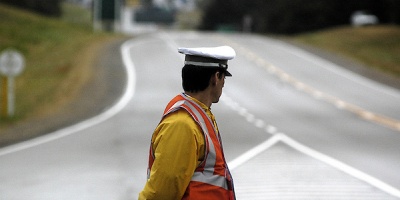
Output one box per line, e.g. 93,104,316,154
0,39,136,156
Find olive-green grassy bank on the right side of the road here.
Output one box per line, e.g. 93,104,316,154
293,26,400,78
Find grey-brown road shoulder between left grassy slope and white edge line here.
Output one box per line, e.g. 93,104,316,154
0,39,126,147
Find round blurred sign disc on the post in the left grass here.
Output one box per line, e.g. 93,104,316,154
0,49,25,77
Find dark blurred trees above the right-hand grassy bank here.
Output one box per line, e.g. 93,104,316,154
201,0,400,34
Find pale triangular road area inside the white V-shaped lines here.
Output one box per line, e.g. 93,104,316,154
232,141,398,200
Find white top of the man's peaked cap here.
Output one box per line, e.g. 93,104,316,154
178,46,236,60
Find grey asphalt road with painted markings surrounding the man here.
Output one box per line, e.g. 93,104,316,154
0,32,400,200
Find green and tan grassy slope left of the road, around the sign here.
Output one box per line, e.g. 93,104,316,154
0,4,118,130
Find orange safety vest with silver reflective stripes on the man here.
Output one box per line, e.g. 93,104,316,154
148,94,236,200
